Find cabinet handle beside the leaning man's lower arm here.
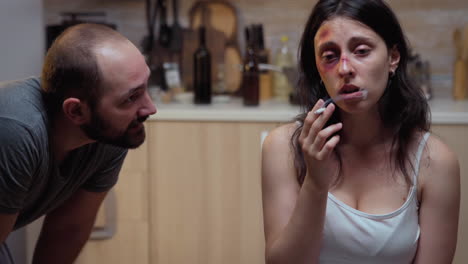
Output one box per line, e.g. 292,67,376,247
89,189,117,240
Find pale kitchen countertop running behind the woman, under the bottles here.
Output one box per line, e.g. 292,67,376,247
150,98,468,125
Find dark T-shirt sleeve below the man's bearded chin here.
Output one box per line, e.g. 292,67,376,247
82,145,127,192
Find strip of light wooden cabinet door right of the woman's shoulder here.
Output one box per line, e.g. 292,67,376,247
432,125,468,264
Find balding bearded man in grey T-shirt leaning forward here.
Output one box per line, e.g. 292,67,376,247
0,24,156,264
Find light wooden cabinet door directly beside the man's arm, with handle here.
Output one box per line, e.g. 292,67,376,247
76,139,149,264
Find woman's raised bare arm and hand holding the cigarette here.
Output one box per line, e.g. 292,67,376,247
262,101,341,264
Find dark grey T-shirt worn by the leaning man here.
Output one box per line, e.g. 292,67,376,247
0,77,127,229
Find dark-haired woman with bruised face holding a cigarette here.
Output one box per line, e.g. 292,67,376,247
262,0,460,264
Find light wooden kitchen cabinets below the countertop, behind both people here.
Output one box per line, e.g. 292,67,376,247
71,120,468,264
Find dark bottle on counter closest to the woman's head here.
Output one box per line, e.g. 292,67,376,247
242,28,260,106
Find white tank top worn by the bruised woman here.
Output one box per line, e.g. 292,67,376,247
320,132,429,264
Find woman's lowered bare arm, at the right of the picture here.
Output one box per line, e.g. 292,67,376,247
414,136,460,264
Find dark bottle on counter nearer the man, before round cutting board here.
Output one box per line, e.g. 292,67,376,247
193,26,211,104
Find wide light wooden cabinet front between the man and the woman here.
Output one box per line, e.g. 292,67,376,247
148,121,277,264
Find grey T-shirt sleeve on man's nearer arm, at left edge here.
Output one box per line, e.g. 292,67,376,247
0,117,40,213
